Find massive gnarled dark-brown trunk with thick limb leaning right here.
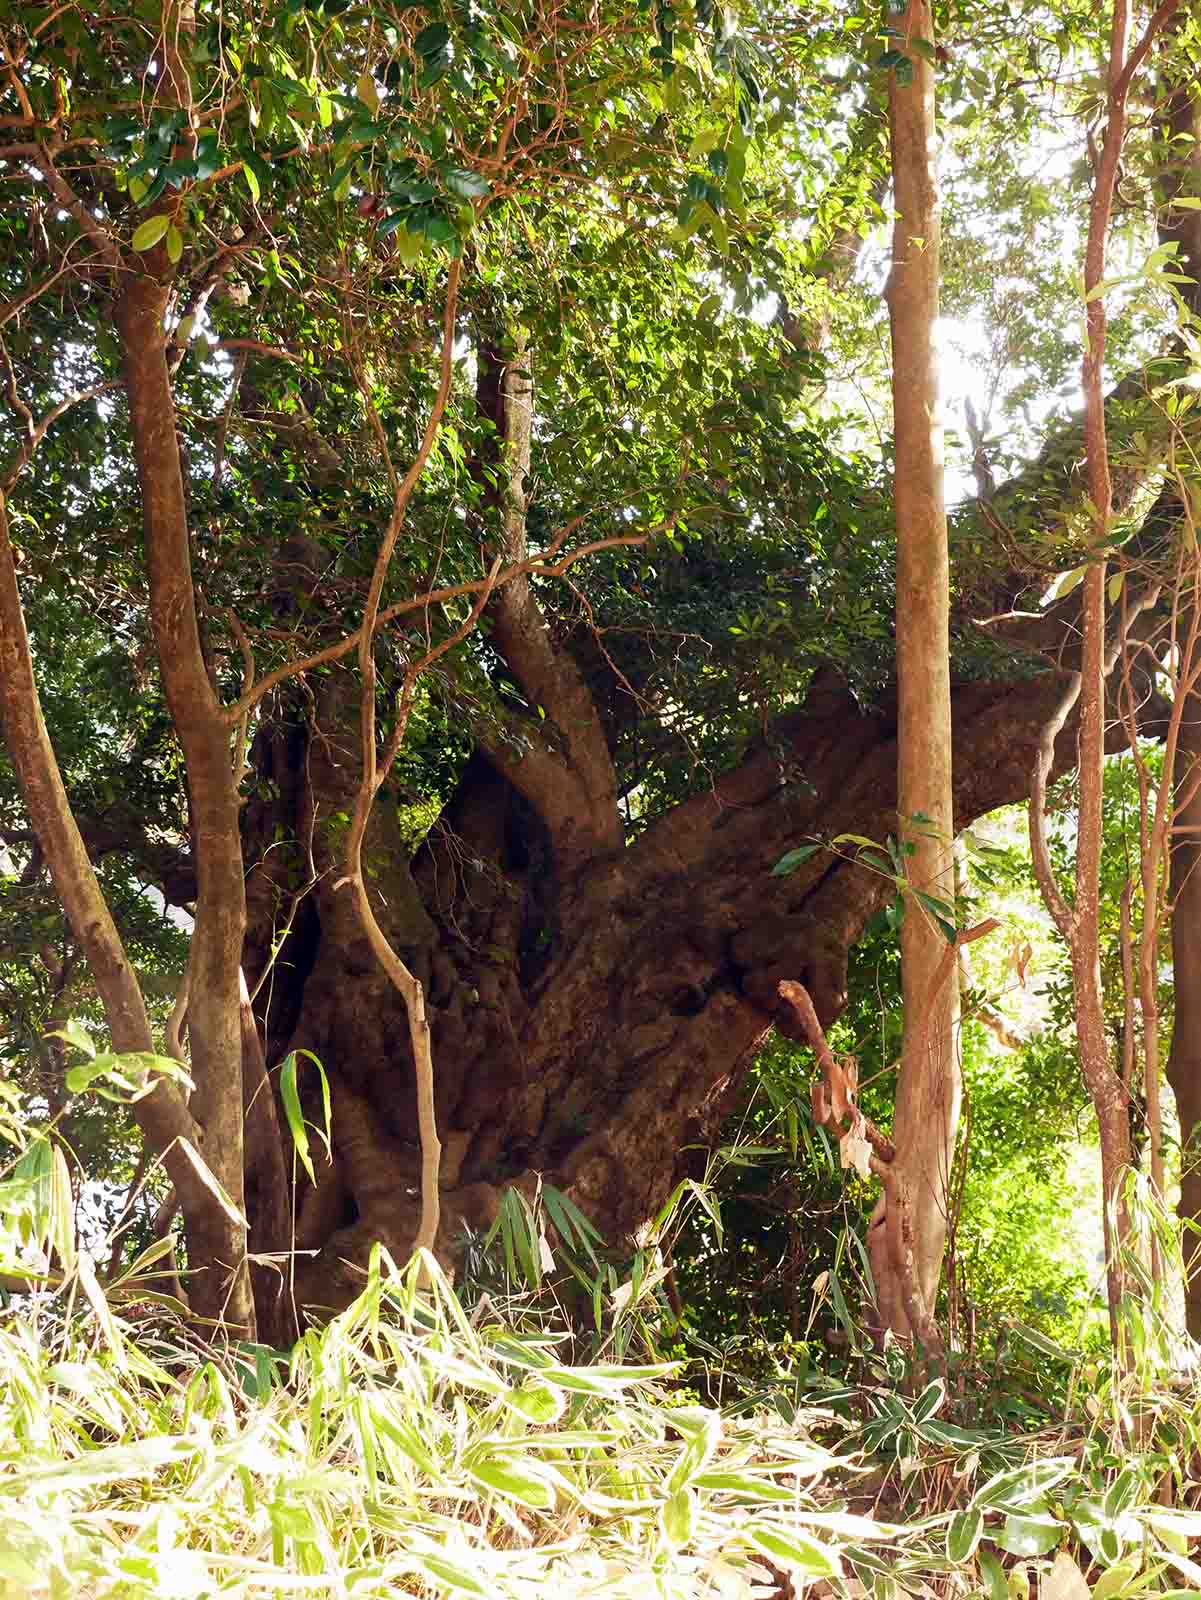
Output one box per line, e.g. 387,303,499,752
245,674,1087,1306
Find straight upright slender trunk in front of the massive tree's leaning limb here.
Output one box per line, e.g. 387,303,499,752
873,0,961,1347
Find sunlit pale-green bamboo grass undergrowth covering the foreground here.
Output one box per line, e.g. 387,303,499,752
0,1081,1201,1600
